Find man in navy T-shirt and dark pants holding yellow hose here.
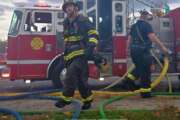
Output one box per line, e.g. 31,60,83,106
120,10,168,98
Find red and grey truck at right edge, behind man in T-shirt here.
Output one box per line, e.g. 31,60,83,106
150,8,180,74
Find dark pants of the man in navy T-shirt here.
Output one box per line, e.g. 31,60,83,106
131,47,153,92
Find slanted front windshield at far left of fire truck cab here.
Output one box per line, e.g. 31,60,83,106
8,11,22,35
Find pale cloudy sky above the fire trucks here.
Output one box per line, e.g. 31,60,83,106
0,0,180,39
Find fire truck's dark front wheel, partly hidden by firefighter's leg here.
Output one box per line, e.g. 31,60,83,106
51,63,65,88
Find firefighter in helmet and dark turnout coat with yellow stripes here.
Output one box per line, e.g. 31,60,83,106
55,1,98,109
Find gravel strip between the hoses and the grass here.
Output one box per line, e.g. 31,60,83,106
0,96,180,111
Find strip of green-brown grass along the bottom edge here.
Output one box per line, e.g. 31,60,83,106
0,106,180,120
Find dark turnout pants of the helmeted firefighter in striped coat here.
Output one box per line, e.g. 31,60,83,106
63,57,92,99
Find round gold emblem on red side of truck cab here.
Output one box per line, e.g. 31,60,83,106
31,37,44,50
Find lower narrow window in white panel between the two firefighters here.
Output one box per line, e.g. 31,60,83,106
115,15,123,33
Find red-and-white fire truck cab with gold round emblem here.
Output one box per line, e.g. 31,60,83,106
7,3,64,86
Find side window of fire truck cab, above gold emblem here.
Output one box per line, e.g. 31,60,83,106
24,12,52,32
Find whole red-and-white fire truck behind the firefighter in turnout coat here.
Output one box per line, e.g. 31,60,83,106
2,0,127,87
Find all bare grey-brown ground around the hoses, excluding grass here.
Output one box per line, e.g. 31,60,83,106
0,77,180,111
